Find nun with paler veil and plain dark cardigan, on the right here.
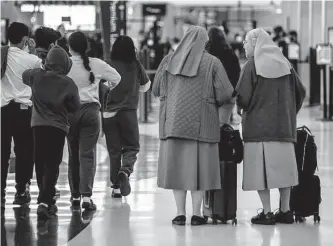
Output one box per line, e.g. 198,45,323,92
236,28,305,225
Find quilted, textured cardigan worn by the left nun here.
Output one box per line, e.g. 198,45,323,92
153,52,234,143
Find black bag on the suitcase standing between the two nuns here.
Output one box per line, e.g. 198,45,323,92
219,124,244,163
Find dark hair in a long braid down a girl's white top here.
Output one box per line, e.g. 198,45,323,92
68,32,95,83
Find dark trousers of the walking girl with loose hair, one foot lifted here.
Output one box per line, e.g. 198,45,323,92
103,110,140,187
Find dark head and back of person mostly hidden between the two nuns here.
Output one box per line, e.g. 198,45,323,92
206,26,241,87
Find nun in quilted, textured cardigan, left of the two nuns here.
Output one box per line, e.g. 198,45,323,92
153,26,234,225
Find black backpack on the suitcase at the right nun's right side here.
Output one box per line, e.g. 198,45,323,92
295,126,318,177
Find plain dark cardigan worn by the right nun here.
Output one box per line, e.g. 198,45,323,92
236,57,306,142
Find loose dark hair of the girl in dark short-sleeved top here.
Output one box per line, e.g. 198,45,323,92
111,36,137,63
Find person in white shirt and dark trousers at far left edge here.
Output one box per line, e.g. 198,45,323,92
1,22,42,207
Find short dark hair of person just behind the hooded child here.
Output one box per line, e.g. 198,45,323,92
35,26,61,49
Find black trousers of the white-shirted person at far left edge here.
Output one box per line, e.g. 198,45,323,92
1,101,34,197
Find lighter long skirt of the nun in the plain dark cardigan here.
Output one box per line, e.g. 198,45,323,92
243,142,298,190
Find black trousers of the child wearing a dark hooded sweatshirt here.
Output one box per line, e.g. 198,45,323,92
33,126,66,204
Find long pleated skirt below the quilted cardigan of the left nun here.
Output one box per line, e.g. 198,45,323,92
157,139,221,191
